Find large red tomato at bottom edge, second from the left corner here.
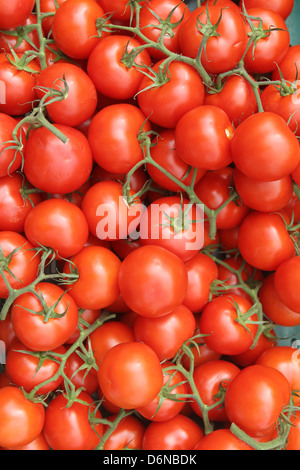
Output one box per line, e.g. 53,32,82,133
43,392,103,450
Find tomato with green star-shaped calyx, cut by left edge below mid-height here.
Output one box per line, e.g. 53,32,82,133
0,231,40,299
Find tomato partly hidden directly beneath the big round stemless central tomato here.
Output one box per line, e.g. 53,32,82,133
133,305,196,361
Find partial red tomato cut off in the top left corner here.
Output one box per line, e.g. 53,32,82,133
0,0,35,29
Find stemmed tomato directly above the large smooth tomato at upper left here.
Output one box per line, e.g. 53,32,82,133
37,62,98,127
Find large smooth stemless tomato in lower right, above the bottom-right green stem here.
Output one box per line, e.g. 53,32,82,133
225,364,291,437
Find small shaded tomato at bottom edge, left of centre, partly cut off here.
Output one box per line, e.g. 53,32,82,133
103,414,145,451
